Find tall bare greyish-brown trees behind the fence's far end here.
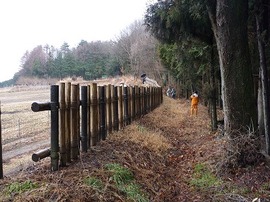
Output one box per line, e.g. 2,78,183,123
115,21,164,81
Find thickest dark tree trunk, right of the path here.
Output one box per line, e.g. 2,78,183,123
214,0,257,137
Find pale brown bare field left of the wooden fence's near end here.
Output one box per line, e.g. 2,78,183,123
0,86,50,175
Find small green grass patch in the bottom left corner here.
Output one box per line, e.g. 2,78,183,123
5,180,38,195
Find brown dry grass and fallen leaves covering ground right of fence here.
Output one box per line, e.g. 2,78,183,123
0,87,270,202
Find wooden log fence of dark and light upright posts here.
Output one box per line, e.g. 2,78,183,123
31,82,163,170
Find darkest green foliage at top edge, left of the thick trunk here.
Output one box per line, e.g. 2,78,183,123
145,0,213,43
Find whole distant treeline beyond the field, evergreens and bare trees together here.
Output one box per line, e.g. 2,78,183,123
14,21,163,84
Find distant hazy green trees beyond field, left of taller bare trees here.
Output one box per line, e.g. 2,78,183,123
20,41,120,80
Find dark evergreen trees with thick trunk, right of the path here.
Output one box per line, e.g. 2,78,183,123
145,0,270,167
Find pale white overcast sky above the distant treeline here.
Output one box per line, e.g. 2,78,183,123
0,0,153,82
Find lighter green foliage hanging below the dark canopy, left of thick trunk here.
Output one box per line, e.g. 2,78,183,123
159,38,211,92
